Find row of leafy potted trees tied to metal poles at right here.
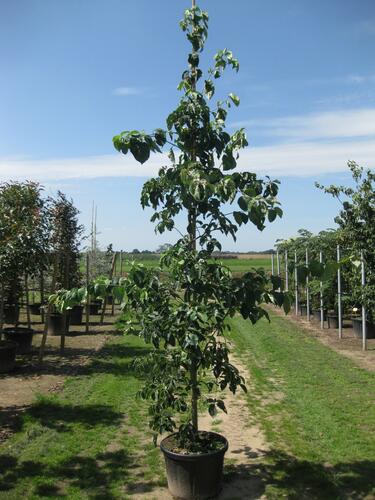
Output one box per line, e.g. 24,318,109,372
277,162,375,338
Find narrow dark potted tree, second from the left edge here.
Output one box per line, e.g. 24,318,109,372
48,191,84,335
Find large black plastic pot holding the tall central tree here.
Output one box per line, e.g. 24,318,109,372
160,432,228,500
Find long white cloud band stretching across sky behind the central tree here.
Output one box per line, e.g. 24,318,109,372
0,140,375,183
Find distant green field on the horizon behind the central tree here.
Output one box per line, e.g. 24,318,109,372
116,254,271,274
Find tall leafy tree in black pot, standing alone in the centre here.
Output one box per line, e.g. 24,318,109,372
114,5,289,498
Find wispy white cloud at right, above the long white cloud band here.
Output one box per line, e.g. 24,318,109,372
232,108,375,141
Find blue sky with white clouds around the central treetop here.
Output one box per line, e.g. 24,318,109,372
0,0,375,251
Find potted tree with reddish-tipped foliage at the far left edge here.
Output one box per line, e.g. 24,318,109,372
0,182,49,356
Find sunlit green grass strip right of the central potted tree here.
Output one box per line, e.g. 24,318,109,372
231,314,375,499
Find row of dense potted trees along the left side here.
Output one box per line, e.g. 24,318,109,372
0,186,83,372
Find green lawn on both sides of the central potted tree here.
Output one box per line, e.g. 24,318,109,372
0,315,375,500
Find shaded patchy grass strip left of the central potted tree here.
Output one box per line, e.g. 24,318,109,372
0,336,165,499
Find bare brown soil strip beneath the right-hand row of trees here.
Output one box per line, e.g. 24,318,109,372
271,307,375,371
